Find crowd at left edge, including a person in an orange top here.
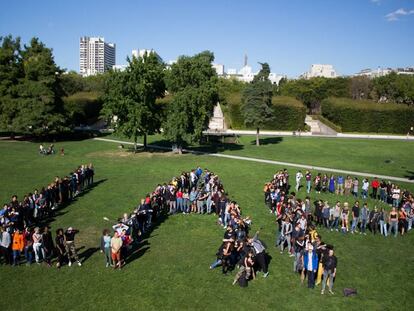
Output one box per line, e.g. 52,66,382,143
0,164,95,268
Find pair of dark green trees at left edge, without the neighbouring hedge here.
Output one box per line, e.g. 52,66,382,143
0,36,67,136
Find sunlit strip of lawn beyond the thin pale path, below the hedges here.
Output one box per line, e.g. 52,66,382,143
111,135,414,178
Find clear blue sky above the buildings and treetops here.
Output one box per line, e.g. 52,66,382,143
0,0,414,77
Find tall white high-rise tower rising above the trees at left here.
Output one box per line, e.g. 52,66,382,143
79,37,115,76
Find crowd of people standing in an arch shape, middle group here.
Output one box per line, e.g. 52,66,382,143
101,167,269,286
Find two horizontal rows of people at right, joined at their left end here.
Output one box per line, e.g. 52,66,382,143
264,170,414,236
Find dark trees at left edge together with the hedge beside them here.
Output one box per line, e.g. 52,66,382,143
0,36,107,136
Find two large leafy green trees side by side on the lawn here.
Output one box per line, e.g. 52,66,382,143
103,51,218,152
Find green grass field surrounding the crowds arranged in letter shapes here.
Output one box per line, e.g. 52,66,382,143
0,138,414,310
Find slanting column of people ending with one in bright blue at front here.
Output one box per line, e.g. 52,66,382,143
264,169,338,294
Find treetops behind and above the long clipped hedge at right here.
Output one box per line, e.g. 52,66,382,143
274,72,414,113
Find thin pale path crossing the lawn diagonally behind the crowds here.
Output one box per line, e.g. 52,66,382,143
94,138,414,184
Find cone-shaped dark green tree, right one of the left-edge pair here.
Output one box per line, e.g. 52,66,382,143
1,38,68,136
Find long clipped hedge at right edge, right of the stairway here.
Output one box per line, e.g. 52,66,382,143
322,98,414,134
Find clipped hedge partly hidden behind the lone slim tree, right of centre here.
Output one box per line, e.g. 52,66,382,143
223,93,306,131
